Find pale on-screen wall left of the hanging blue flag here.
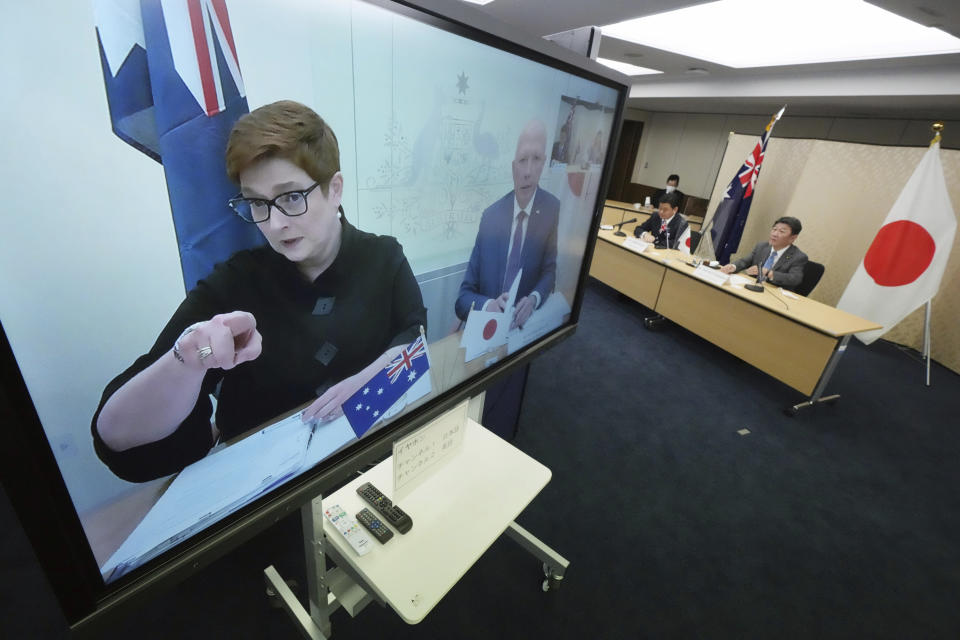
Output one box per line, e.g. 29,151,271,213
0,0,183,510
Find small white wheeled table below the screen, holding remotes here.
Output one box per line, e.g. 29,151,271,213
266,420,568,638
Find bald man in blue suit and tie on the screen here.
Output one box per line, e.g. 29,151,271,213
455,120,560,328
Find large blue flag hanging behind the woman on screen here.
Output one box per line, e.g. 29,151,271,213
94,0,263,291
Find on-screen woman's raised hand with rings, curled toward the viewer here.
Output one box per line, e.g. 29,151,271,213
177,311,263,370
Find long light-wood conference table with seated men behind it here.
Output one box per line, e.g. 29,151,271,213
590,215,880,415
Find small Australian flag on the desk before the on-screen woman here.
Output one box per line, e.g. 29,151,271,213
341,335,431,438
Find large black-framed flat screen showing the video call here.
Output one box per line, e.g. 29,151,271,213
0,0,626,623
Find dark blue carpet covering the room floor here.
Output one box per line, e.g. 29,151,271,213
0,281,960,639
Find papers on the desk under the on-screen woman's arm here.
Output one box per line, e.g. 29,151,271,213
100,412,356,578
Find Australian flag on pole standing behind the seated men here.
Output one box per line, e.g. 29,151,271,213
710,107,786,264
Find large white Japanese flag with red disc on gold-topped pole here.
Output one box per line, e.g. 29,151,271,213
837,141,957,344
